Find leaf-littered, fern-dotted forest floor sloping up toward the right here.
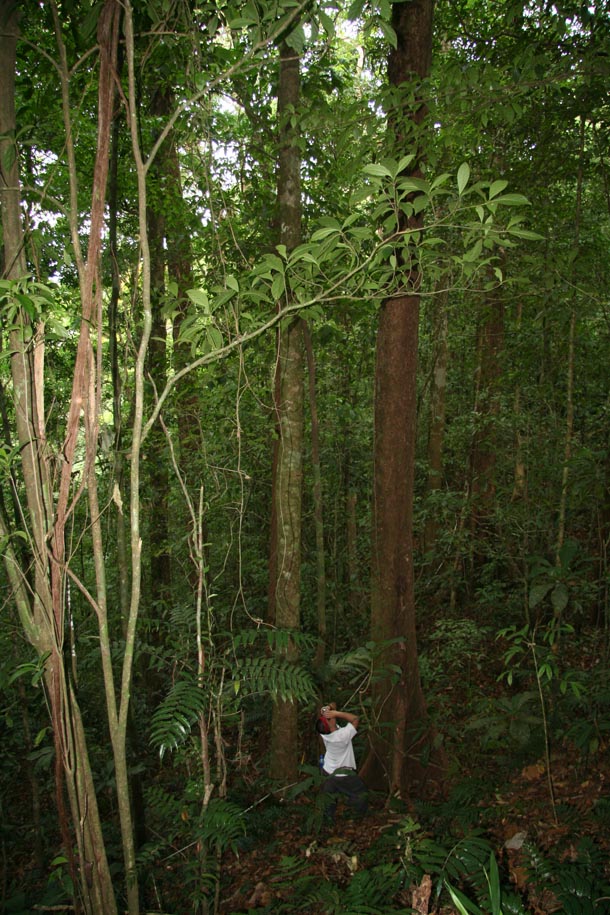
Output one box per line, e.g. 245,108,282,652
207,628,610,915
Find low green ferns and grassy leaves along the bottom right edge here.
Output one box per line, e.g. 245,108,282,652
222,800,610,915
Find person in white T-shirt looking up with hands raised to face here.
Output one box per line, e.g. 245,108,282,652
316,702,368,821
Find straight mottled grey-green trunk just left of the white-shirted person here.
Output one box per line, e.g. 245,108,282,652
271,42,304,782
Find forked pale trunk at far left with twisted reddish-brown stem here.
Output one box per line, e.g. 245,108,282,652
0,0,117,915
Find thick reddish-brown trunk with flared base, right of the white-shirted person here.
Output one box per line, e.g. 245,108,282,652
363,0,439,797
